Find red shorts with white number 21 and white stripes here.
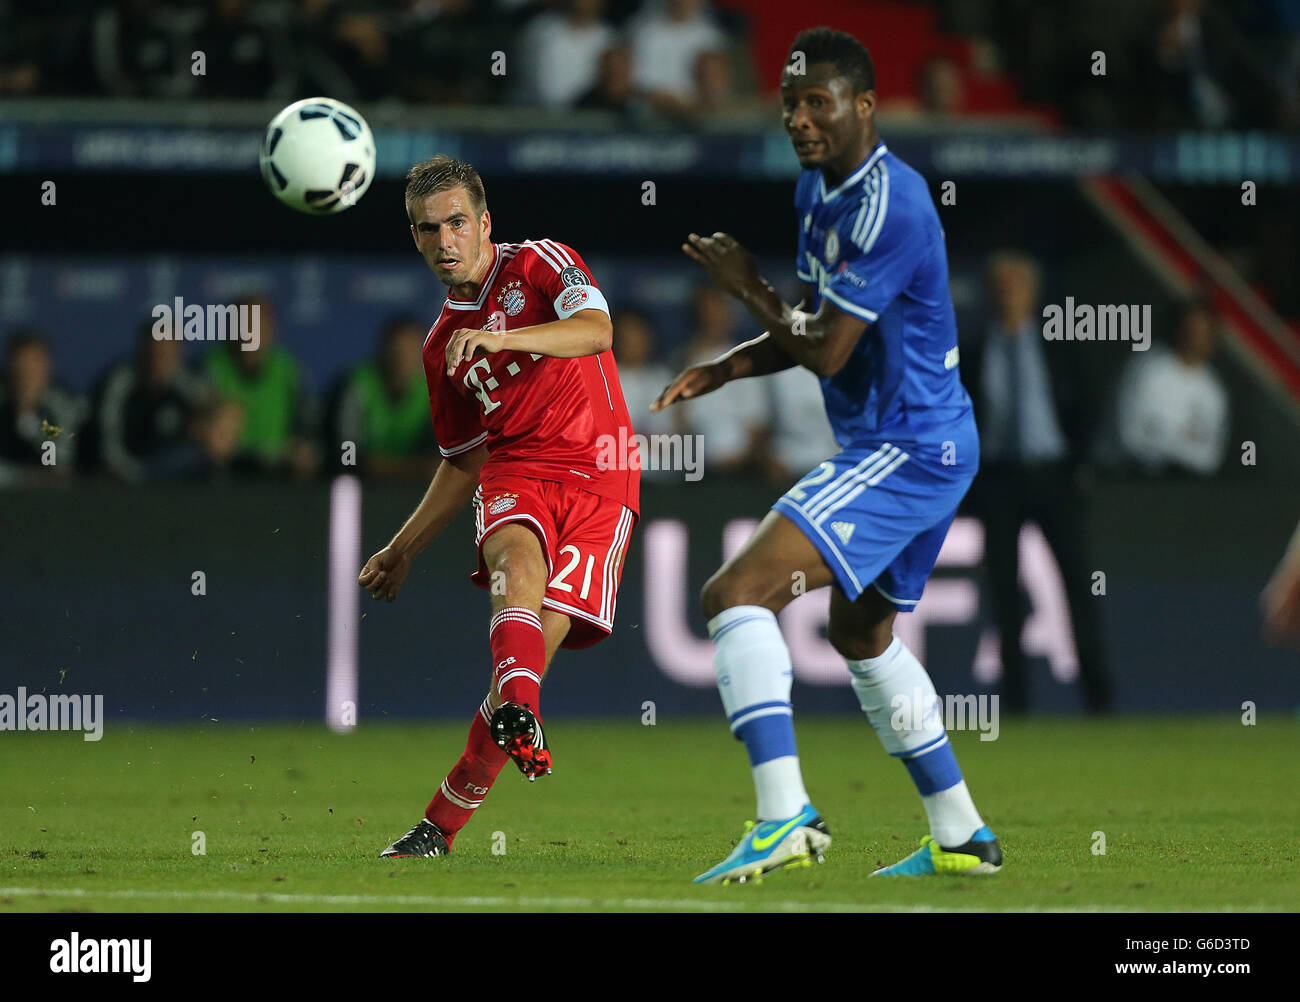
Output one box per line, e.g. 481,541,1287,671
469,477,637,649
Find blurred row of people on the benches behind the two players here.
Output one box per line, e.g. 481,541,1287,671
0,251,1231,493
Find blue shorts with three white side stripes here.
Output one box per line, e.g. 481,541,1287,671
772,442,978,612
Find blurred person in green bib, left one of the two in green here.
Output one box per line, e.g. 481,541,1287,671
205,299,320,477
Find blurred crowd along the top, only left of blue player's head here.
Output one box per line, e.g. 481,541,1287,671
0,0,753,123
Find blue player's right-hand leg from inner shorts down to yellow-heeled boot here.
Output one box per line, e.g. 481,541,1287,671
827,517,1002,876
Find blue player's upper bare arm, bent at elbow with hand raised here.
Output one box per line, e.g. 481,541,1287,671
681,233,867,379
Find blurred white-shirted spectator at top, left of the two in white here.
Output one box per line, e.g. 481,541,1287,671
519,0,618,108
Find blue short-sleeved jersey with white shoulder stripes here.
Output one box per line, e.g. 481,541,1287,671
794,143,974,447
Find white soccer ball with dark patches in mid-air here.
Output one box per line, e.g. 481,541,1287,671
260,97,374,216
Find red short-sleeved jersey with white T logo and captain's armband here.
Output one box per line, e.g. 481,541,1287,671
424,239,640,512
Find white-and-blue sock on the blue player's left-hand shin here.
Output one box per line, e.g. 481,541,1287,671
709,606,809,821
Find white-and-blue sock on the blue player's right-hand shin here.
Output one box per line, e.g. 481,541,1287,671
846,637,984,846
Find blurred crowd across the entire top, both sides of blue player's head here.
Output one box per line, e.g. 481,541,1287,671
0,0,1300,129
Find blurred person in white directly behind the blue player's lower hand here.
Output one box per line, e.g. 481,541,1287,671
676,283,764,473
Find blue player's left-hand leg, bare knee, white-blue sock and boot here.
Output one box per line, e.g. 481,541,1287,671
696,511,833,884
